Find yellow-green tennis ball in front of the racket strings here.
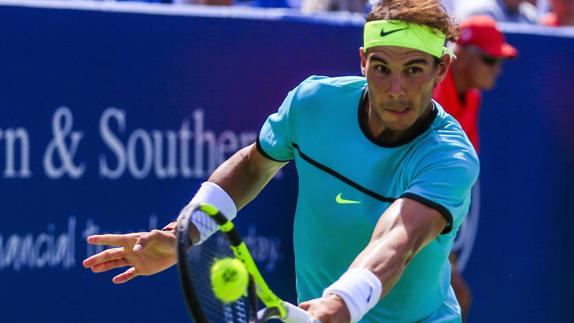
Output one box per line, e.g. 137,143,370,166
210,258,249,304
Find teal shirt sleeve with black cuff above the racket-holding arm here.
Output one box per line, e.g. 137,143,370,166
400,147,479,234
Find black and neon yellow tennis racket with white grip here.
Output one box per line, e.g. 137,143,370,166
177,204,320,323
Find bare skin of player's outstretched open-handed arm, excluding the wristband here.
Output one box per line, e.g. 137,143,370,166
83,144,286,284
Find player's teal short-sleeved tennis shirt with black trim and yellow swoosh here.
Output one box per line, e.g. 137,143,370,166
257,76,479,323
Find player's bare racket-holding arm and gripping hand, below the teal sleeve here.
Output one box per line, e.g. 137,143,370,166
301,198,448,323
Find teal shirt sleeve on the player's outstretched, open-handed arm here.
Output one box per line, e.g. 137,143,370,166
257,89,297,162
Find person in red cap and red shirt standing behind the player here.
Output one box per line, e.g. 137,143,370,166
433,16,517,317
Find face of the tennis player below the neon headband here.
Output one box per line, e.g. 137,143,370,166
361,46,448,130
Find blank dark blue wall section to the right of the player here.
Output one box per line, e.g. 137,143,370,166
465,32,574,322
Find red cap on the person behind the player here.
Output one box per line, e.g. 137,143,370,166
456,16,518,58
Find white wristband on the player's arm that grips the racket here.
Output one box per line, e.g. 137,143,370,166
323,268,383,322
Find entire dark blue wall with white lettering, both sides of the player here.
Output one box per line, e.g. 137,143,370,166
0,5,574,322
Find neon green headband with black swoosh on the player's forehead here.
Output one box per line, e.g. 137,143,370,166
363,20,450,58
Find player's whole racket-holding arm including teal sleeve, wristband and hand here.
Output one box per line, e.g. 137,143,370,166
301,140,479,323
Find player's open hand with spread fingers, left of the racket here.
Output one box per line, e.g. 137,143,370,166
83,230,177,284
